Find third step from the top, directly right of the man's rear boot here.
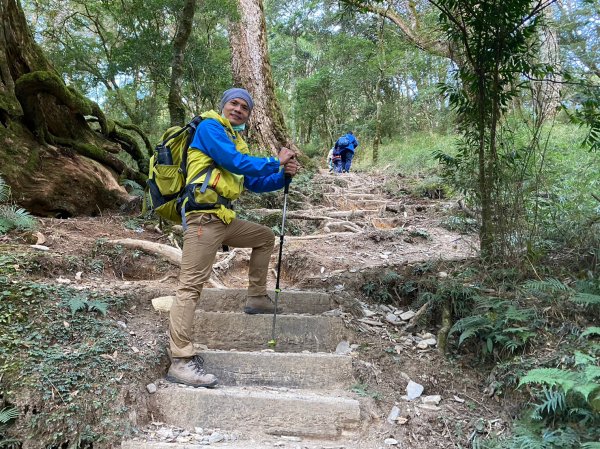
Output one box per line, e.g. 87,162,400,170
200,351,353,390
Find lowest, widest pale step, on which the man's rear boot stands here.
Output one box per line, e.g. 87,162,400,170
150,382,360,438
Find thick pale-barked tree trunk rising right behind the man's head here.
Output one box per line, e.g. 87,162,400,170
229,0,299,154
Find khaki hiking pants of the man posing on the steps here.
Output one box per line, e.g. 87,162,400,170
169,213,275,357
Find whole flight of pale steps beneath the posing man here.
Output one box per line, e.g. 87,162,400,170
122,289,363,449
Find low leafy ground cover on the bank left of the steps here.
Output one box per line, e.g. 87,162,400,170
0,272,159,448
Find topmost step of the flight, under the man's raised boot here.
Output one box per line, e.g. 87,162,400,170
198,288,334,315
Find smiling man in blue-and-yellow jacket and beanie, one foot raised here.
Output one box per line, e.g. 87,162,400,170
167,88,299,387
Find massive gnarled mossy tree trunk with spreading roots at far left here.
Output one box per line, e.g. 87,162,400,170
0,0,147,217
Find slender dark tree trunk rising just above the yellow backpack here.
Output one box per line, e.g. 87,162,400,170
169,0,196,126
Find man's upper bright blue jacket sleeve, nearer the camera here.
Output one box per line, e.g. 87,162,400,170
190,119,280,177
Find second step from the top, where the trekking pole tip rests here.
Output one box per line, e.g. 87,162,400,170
194,310,350,352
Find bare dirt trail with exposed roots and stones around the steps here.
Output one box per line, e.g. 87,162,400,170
7,171,505,449
